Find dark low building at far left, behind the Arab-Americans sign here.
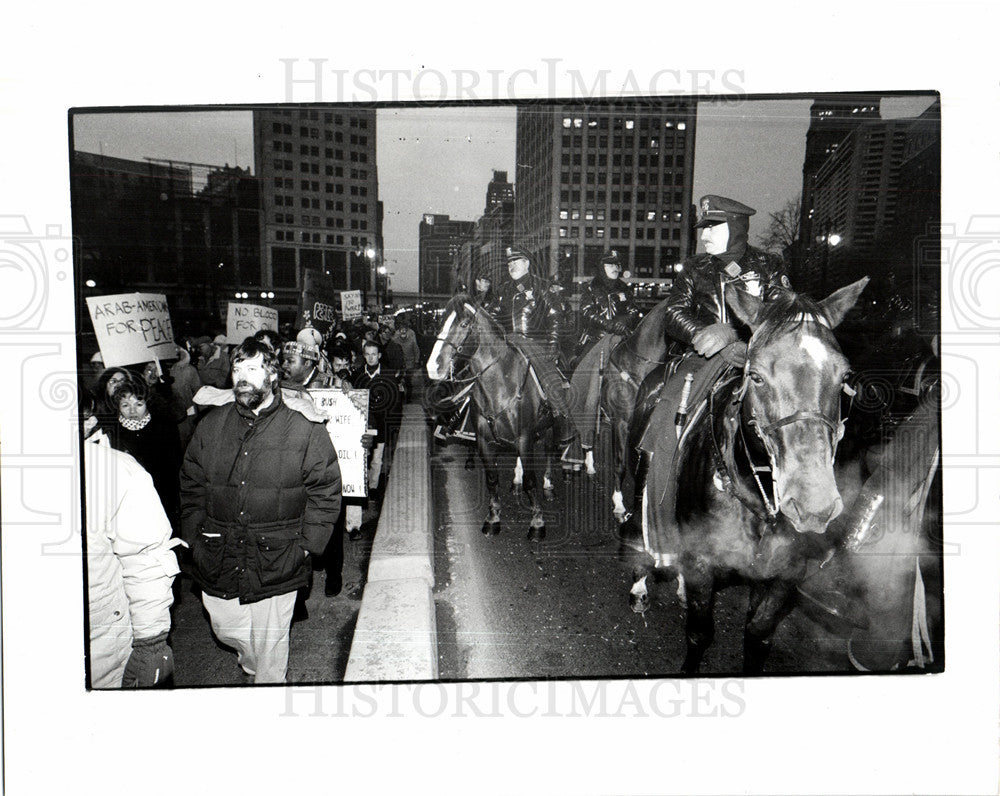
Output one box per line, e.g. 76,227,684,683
70,152,260,334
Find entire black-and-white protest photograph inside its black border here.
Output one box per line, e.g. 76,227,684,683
70,92,945,687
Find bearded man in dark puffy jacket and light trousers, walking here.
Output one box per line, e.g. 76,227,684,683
181,337,341,683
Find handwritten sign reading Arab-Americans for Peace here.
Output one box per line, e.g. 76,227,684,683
87,293,177,368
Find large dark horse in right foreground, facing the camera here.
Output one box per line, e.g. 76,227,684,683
644,278,868,674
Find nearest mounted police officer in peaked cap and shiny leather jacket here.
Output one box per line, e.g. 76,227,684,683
664,194,791,364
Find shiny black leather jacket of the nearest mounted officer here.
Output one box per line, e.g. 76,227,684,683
663,247,791,345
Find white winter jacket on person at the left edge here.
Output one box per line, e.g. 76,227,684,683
83,442,179,688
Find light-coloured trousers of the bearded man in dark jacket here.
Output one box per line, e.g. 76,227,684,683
201,592,295,683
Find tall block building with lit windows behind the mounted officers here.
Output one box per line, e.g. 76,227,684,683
515,98,696,298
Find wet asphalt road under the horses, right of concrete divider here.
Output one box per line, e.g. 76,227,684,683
433,426,850,680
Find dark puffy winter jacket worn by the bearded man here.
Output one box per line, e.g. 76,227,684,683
181,391,340,603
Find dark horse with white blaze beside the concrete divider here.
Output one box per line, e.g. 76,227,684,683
427,295,553,540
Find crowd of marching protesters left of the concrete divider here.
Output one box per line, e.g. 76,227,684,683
79,310,422,688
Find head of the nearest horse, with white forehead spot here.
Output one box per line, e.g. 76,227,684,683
730,277,868,533
